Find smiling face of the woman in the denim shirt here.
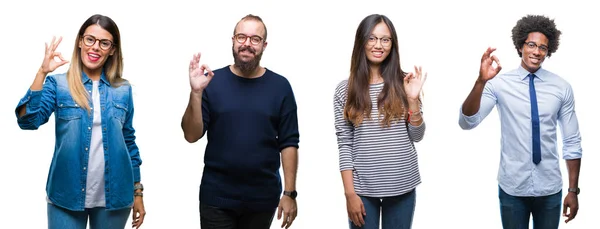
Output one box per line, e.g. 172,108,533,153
78,24,115,76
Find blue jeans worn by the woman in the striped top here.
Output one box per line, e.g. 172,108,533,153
350,189,417,229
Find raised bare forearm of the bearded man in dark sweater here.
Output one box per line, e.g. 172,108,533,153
181,92,204,143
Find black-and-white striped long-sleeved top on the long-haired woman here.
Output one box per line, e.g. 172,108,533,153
334,80,425,197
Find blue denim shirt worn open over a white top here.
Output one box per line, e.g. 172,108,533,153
15,73,142,211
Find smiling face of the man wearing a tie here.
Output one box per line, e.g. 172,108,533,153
519,32,548,72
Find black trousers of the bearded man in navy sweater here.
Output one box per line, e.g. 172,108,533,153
200,203,276,229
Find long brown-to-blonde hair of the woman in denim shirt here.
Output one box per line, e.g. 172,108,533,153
67,14,124,111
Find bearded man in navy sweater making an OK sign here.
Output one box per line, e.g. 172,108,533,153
181,14,299,229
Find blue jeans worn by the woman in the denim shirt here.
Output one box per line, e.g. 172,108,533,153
48,203,131,229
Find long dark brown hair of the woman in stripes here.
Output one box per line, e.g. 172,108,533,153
344,14,408,126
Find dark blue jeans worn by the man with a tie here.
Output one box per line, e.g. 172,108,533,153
498,187,562,229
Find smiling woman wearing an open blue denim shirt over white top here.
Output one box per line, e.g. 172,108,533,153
15,15,146,229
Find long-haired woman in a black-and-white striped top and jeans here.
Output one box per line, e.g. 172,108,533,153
334,14,427,229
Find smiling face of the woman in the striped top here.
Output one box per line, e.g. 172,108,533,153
365,22,392,65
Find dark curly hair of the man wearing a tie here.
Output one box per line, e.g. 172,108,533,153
512,15,561,57
